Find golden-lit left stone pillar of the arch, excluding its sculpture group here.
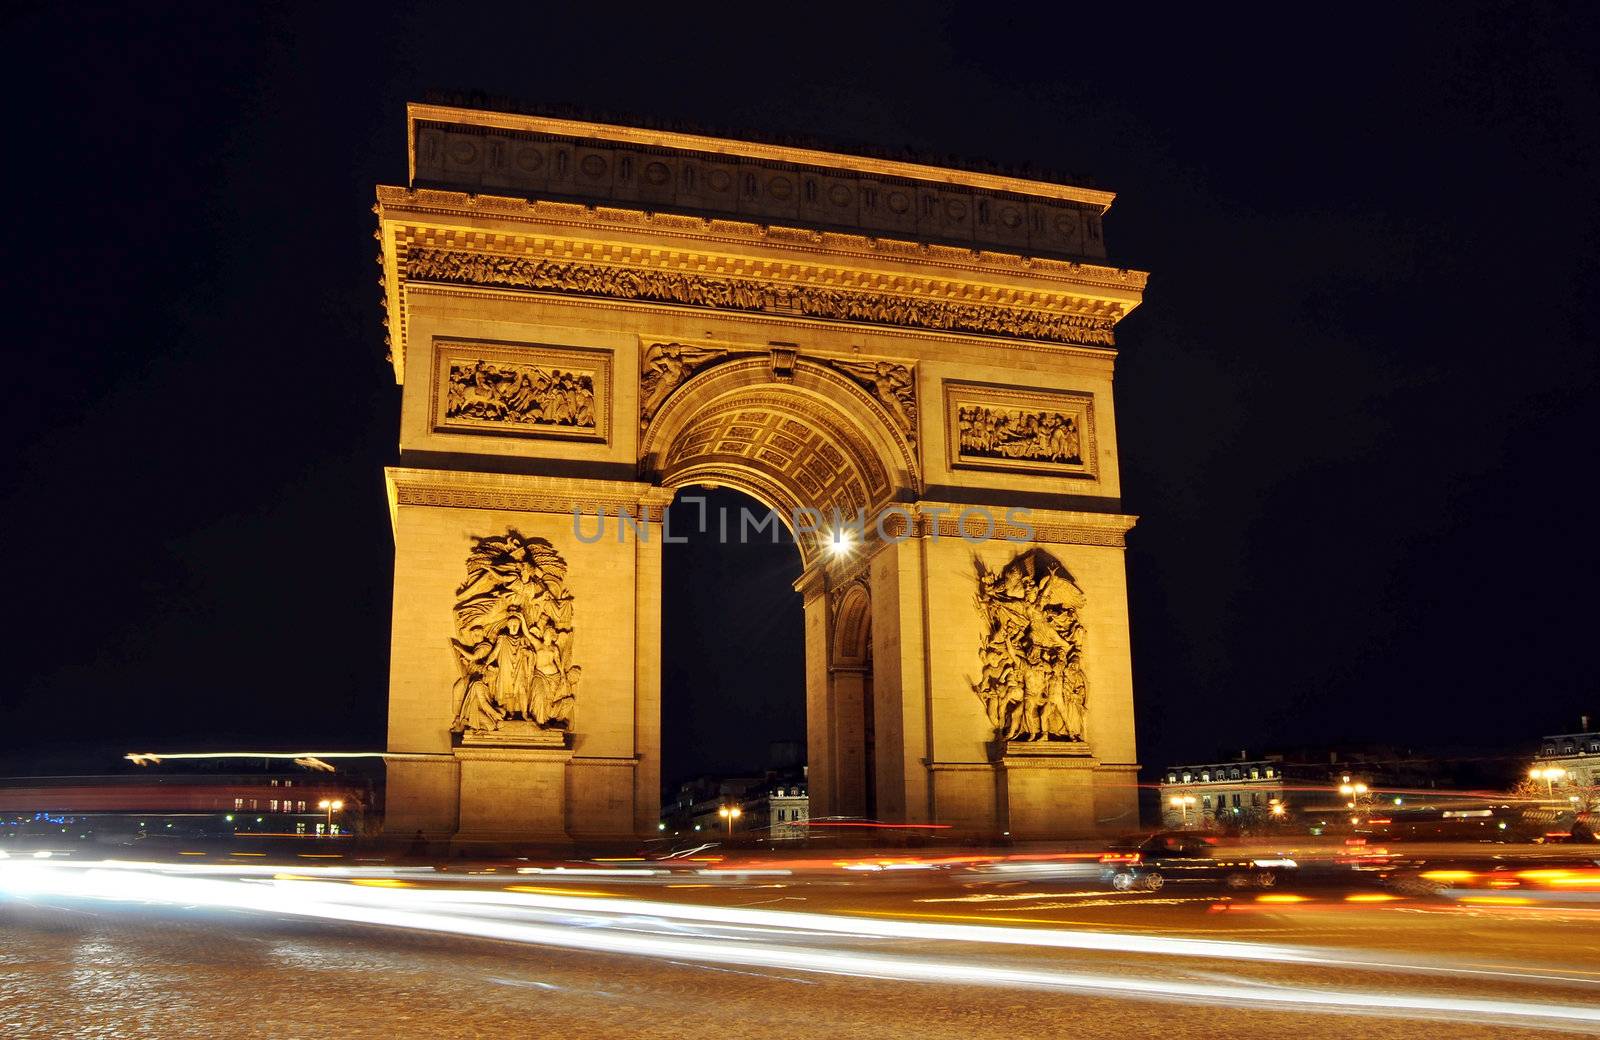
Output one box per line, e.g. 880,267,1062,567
386,469,667,842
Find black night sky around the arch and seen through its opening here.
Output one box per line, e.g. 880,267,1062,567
0,3,1600,773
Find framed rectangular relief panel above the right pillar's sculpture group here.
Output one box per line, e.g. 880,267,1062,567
946,382,1094,477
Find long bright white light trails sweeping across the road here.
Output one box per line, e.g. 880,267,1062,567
0,859,1600,1027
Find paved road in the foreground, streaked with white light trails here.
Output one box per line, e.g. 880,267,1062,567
0,859,1600,1040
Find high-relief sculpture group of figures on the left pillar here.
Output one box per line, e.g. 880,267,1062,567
450,531,581,733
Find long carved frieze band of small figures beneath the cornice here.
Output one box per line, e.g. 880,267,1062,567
405,246,1115,347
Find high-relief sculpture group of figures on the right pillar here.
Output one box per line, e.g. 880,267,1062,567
973,549,1090,741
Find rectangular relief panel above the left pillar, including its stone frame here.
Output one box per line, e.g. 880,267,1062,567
435,342,610,440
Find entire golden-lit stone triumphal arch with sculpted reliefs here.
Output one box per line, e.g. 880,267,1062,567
376,104,1146,842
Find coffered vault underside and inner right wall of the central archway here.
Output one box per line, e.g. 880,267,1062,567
640,357,920,818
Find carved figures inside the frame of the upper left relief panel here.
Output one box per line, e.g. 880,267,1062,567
445,360,595,429
